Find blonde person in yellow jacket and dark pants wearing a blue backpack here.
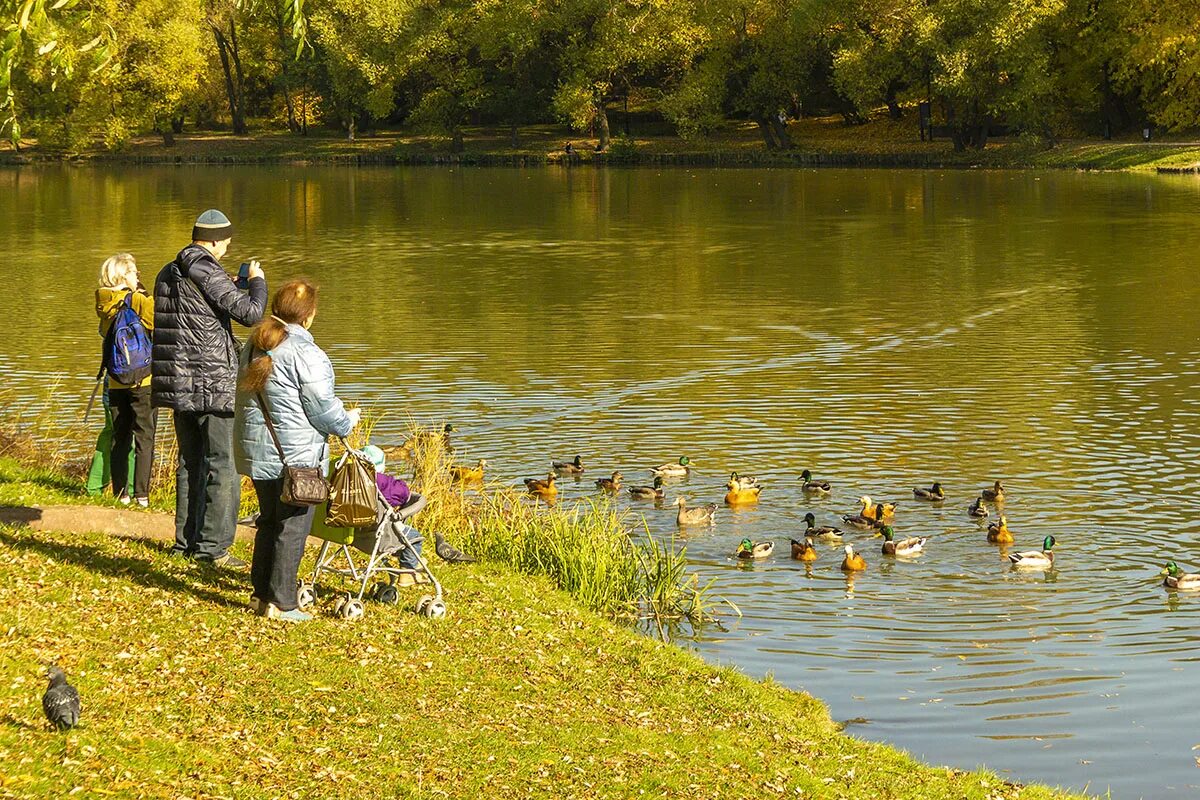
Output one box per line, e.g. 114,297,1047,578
96,253,157,507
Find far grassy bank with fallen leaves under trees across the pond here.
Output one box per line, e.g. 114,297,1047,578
0,115,1200,172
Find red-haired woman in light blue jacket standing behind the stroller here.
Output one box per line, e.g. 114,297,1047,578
234,278,359,622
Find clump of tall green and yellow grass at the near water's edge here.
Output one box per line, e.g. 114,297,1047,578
381,421,715,622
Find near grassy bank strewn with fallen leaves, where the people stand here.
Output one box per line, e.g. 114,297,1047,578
0,459,1089,800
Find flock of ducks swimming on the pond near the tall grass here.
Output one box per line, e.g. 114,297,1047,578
511,456,1065,575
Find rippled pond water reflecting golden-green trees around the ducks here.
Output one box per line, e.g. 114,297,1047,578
0,167,1200,798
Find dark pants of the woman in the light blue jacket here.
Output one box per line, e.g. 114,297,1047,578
250,477,316,612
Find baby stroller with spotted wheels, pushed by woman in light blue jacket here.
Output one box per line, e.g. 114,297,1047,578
296,479,446,620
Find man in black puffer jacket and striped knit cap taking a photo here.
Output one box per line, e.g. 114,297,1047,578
151,210,266,567
